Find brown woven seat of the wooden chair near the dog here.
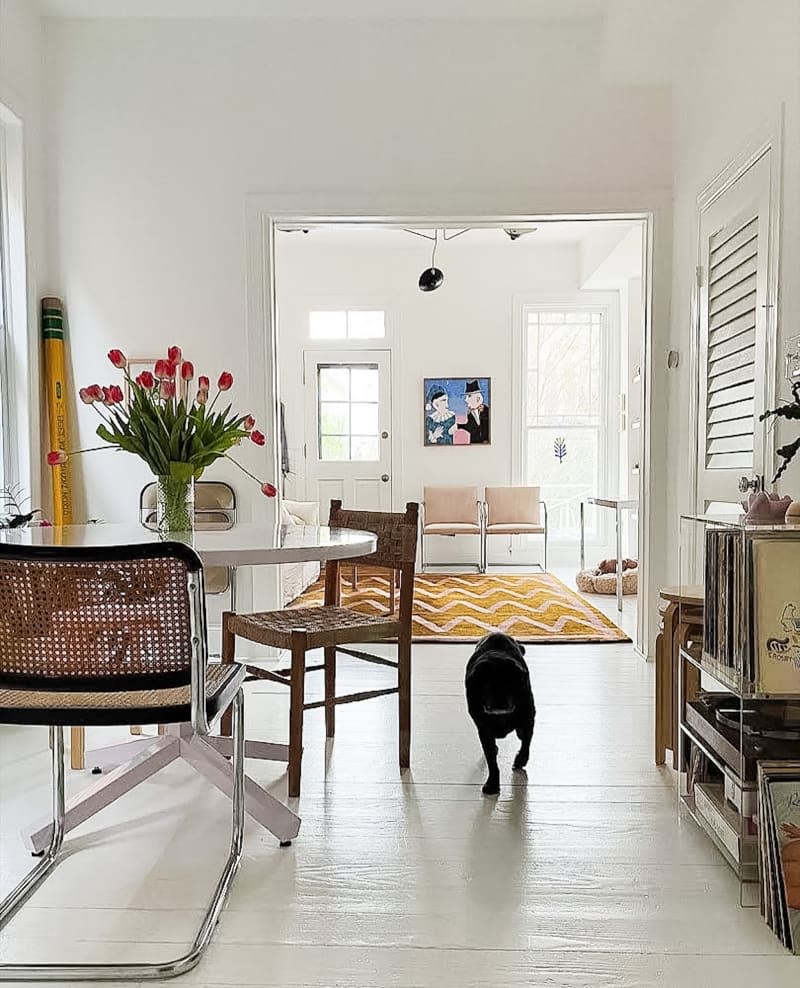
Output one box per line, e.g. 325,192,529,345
228,607,400,648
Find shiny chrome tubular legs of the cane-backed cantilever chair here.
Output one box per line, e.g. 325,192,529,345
0,704,245,983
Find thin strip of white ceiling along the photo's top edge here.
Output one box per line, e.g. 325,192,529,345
39,0,608,20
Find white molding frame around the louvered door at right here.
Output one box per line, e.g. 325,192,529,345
689,119,783,512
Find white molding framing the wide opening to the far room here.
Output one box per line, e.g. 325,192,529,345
245,200,656,658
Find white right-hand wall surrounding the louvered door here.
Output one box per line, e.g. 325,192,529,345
660,0,800,582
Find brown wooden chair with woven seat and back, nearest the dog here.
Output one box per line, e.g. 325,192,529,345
222,501,419,797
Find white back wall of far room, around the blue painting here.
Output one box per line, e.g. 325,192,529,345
277,233,619,565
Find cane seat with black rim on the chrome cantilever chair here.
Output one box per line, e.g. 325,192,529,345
0,664,243,727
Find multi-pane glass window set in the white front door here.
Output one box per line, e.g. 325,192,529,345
317,364,380,462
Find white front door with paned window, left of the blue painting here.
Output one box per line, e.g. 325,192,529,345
304,350,392,519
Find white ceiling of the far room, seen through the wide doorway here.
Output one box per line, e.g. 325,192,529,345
278,220,634,250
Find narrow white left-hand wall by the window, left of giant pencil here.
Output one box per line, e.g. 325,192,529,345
0,0,49,505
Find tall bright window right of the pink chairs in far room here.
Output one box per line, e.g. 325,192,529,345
523,307,606,541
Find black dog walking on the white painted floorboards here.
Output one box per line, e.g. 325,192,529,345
464,632,536,796
